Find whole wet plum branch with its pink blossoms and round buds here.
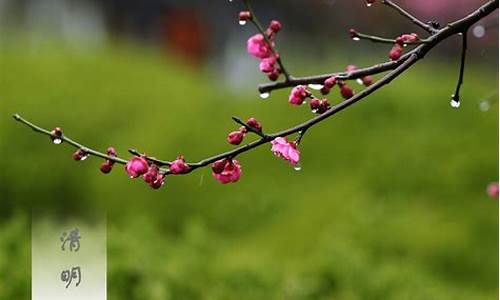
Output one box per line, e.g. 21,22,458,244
13,0,499,188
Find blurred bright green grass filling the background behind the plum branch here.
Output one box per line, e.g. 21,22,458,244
0,43,498,300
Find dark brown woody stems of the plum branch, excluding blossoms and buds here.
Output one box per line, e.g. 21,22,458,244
14,0,499,180
